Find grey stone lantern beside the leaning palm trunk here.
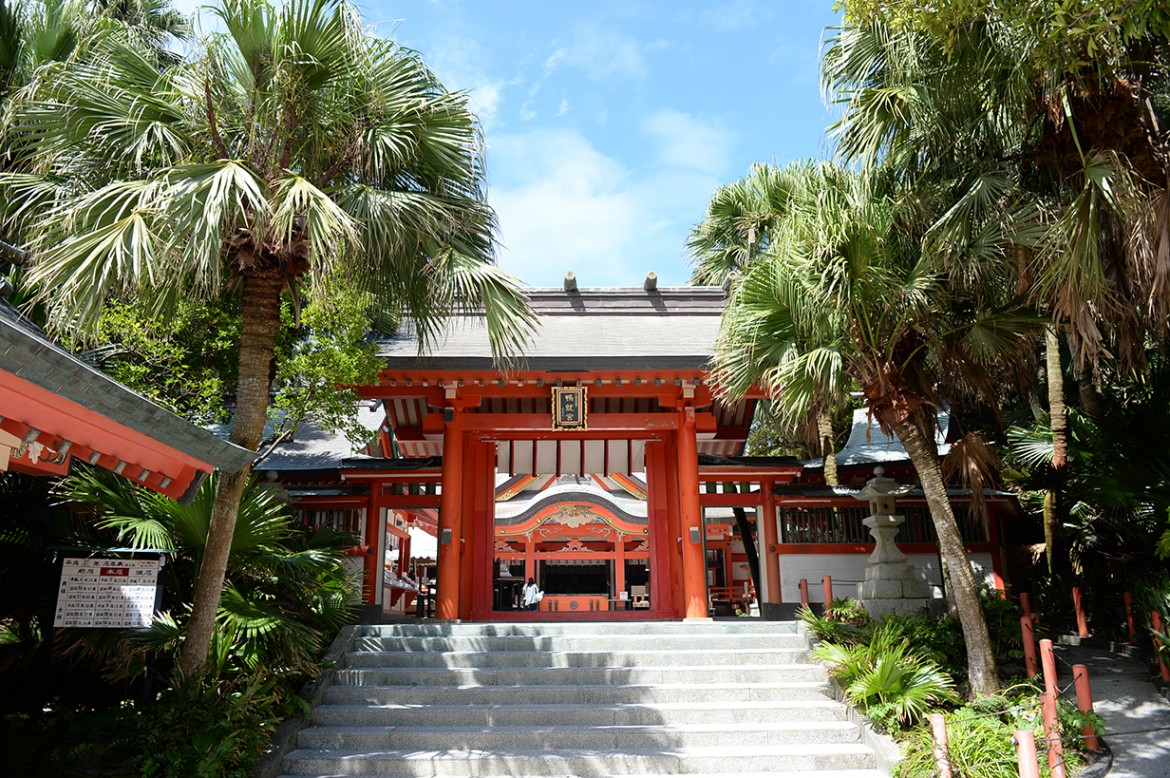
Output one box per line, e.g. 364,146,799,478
854,467,930,617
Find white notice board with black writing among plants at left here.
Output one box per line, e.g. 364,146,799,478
53,558,163,628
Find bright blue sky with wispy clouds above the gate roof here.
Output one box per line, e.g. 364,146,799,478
177,0,835,287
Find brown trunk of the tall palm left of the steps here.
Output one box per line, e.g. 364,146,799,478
179,273,284,679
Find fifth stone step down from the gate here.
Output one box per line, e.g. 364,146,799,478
324,679,832,707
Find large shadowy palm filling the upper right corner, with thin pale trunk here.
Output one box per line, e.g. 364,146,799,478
824,2,1170,570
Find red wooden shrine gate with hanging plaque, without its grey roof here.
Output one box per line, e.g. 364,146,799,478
346,370,799,620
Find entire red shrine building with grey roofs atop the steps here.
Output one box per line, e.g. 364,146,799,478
257,274,1014,621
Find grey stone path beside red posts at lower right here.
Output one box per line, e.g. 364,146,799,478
1054,645,1170,778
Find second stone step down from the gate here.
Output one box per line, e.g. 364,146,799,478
353,632,806,653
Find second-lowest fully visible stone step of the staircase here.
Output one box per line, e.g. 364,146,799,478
298,721,860,752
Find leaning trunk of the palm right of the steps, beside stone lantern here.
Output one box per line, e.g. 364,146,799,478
892,418,999,697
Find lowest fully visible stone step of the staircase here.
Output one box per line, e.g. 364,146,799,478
276,743,875,778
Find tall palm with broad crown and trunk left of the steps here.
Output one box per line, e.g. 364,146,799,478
0,0,532,675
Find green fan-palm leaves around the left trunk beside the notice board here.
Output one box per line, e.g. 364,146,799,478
62,470,359,679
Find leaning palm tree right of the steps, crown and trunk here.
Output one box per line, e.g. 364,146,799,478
715,164,1027,694
